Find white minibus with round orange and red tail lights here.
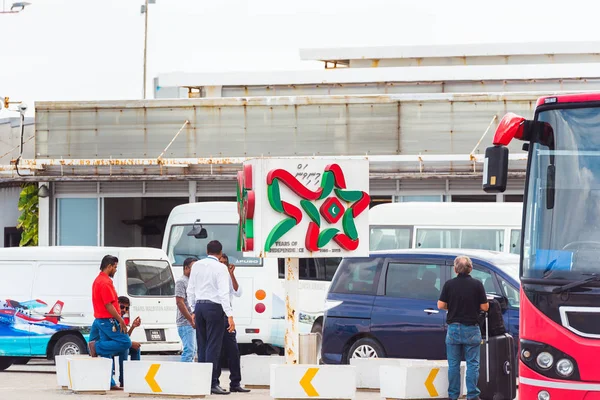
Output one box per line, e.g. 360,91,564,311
163,201,285,354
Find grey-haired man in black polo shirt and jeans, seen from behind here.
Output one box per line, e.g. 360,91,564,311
438,256,489,400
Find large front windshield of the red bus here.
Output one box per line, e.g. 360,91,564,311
523,108,600,280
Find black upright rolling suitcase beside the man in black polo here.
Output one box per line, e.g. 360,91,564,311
477,313,517,400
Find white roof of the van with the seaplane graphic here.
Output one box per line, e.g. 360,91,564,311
0,246,167,267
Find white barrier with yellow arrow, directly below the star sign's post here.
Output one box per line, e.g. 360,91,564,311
271,364,356,399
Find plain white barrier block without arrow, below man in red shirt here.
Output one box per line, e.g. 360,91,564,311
67,356,112,394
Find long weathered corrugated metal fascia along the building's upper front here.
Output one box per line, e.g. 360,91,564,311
36,93,538,159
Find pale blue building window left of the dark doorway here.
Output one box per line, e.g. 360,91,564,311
56,198,101,246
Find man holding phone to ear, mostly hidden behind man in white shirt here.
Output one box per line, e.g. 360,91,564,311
218,253,250,393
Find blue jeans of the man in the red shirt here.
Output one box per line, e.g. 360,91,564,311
89,318,131,387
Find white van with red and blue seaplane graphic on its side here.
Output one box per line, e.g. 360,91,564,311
0,247,181,370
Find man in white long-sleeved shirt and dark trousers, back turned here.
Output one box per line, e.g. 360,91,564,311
187,240,235,394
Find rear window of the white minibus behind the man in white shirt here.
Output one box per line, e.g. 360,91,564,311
167,224,262,266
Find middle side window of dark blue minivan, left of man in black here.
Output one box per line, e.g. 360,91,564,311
385,263,442,300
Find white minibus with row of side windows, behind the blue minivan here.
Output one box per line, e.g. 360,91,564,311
369,202,523,254
